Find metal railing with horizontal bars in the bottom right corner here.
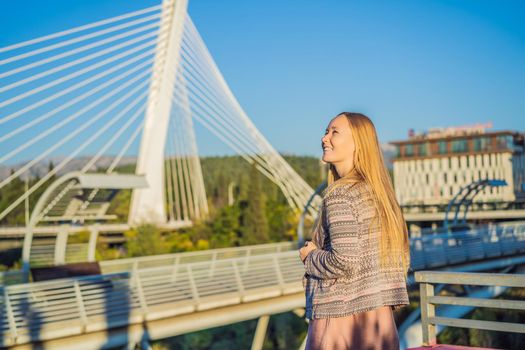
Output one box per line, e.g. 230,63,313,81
415,271,525,345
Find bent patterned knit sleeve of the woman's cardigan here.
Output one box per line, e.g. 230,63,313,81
305,192,360,279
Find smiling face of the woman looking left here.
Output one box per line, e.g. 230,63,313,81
321,115,355,170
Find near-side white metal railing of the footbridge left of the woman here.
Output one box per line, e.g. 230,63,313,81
0,251,304,346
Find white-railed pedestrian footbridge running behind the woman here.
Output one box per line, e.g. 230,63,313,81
0,222,525,348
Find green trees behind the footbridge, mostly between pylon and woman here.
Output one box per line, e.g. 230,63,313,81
98,156,322,259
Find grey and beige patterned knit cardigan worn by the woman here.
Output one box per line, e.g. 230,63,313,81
303,181,408,319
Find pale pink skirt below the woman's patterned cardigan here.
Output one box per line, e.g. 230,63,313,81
306,306,399,350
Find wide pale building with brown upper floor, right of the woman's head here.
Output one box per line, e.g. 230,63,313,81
391,125,525,206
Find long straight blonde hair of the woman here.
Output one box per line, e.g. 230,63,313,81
327,112,410,273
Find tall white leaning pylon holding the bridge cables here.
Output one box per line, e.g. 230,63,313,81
128,0,188,225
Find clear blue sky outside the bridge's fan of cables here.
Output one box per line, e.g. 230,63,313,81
0,0,525,155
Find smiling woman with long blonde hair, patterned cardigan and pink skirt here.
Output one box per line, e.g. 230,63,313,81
299,112,410,350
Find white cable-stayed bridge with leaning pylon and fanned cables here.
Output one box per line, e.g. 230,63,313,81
0,0,318,232
